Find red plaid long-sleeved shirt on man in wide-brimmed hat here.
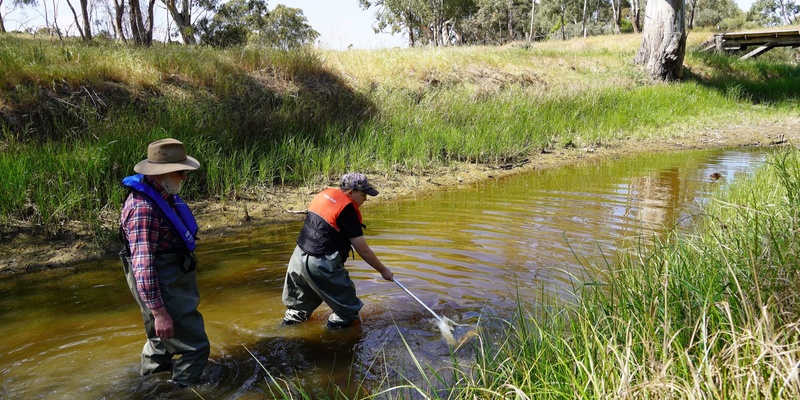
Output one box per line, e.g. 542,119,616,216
120,176,182,310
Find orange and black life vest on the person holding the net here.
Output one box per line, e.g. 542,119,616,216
297,188,362,260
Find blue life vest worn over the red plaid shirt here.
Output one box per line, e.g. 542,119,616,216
122,174,197,252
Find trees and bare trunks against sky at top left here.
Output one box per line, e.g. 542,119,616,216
0,0,319,49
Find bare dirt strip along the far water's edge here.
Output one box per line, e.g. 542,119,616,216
0,118,800,276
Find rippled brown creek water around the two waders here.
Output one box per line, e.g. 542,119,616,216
0,149,765,399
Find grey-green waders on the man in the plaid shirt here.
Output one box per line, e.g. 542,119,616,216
120,251,211,384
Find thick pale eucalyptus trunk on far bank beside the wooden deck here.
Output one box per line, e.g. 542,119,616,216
633,0,686,81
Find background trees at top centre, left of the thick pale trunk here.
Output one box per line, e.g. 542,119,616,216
359,0,680,46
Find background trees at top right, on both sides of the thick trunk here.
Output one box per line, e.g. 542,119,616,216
359,0,800,46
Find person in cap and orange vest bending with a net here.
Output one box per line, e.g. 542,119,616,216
283,173,394,329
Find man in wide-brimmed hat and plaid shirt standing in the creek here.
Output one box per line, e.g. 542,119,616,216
120,139,210,386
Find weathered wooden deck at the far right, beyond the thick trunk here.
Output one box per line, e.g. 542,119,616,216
703,29,800,60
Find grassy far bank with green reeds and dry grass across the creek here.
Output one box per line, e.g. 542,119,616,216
0,35,800,241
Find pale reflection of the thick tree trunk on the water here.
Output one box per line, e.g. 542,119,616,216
629,168,681,232
